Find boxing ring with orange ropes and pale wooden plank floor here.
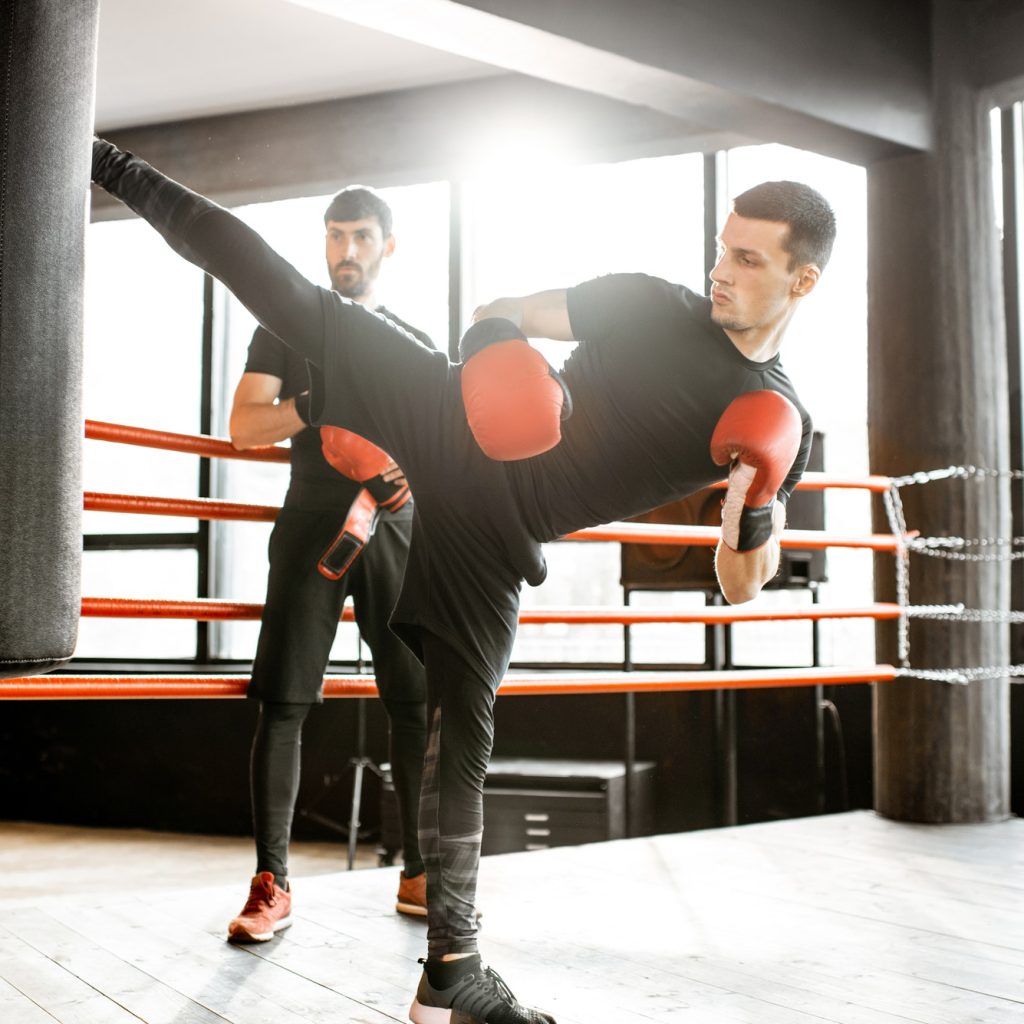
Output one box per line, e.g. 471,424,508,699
0,423,1024,1024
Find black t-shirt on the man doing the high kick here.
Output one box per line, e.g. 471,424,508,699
518,273,812,540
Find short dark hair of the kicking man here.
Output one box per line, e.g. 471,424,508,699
732,181,836,270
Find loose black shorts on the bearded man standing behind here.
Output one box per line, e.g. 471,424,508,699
249,504,426,703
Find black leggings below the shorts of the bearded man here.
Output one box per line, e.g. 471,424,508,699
249,700,425,882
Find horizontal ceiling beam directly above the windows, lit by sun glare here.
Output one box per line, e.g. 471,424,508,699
92,75,751,220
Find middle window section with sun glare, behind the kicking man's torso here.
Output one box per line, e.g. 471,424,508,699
463,155,703,663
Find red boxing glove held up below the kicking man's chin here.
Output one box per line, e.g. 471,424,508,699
711,391,804,551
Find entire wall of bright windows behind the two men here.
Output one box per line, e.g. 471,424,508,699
79,145,873,665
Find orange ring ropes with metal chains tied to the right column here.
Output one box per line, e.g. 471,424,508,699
0,420,1024,700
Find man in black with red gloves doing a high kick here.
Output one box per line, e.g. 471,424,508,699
92,139,835,1024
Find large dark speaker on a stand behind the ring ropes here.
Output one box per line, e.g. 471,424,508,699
621,431,827,590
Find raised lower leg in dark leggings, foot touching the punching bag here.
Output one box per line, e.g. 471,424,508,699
92,139,326,366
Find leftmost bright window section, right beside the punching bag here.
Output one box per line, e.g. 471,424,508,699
76,220,203,658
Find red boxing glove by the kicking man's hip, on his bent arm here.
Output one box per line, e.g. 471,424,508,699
459,316,572,462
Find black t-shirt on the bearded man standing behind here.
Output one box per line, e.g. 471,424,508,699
245,306,434,510
